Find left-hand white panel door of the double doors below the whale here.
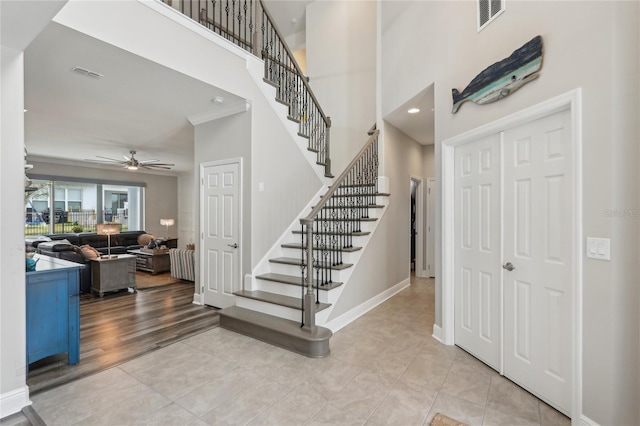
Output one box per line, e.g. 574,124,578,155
454,134,502,370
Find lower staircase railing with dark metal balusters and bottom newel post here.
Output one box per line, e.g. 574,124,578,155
300,126,379,330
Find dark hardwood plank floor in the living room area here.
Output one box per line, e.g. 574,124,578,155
27,274,219,394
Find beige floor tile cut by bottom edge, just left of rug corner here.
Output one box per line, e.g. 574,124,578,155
367,382,438,426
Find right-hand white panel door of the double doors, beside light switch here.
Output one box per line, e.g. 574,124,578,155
503,110,573,413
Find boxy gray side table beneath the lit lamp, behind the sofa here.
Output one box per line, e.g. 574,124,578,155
91,254,136,297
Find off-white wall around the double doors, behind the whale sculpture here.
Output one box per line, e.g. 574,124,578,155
382,1,640,424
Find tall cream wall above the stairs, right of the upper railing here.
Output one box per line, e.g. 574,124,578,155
306,1,376,176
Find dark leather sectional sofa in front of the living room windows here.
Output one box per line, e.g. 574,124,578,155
25,231,150,292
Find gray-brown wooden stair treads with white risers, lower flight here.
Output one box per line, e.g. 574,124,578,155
220,186,388,357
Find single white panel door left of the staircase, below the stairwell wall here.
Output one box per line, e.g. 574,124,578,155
201,160,242,308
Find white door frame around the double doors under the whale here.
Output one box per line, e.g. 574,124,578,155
440,88,583,424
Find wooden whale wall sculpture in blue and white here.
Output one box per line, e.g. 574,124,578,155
451,36,542,114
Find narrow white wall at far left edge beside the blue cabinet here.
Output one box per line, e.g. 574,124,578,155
0,46,30,418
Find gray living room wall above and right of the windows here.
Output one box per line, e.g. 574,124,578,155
31,160,182,243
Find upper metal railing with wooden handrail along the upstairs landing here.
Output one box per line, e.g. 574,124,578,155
168,0,332,176
